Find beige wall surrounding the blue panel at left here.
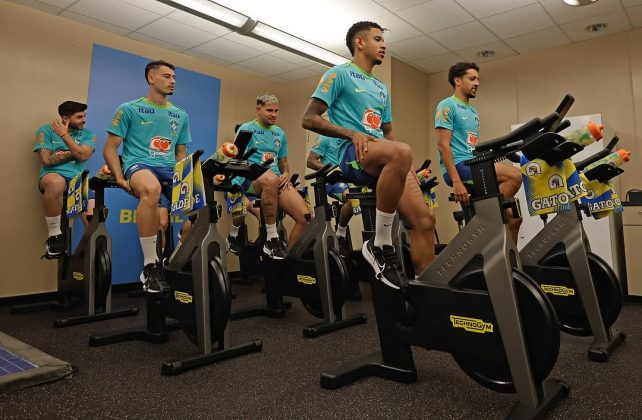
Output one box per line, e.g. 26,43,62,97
0,1,278,297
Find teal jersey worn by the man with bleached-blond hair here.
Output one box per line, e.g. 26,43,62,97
237,120,288,176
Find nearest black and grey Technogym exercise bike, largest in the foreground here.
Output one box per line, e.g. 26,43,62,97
320,113,569,419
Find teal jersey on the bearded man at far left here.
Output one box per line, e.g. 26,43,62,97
33,124,96,178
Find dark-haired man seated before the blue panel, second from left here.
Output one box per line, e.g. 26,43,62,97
104,61,192,293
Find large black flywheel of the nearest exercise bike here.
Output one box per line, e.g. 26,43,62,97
442,270,560,392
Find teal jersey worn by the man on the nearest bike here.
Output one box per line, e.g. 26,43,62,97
312,62,392,162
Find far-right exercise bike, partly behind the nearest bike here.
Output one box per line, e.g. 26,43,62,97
520,101,625,362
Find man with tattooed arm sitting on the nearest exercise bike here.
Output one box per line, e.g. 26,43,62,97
303,22,435,289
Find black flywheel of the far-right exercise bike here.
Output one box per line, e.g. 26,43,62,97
541,250,622,337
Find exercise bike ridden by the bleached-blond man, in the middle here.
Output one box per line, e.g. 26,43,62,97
232,165,367,338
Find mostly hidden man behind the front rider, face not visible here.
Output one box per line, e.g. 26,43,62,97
307,137,353,257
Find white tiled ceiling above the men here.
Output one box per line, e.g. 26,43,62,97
8,0,642,83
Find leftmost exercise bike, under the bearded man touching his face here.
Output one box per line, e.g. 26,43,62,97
11,170,138,328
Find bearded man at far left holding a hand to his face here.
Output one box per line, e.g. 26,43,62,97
33,101,96,259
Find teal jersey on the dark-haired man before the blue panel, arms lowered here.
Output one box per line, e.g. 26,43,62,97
107,97,192,172
